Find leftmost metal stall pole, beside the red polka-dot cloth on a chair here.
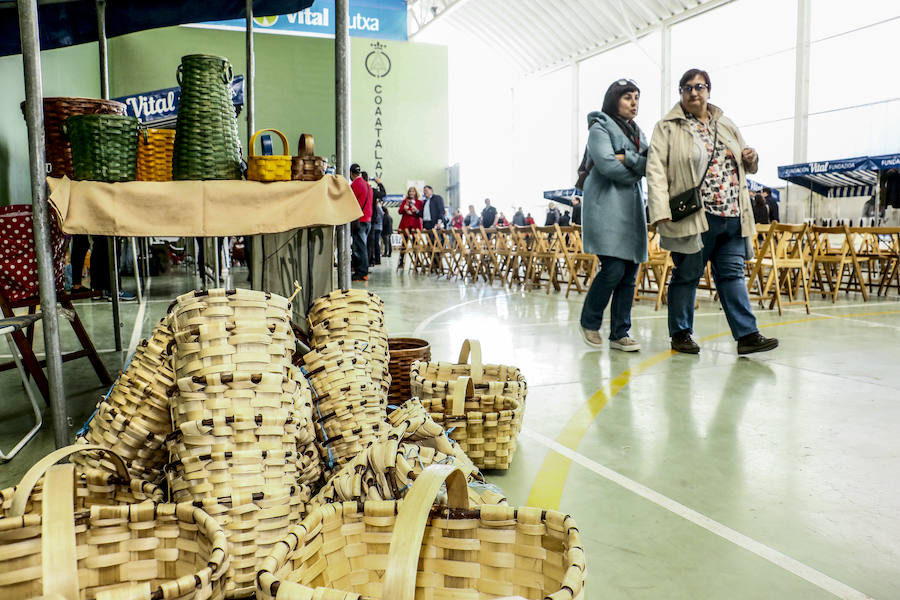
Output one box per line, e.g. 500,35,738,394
17,0,71,448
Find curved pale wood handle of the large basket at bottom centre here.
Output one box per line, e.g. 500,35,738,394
381,465,469,600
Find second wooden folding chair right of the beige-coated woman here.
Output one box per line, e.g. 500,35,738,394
812,225,869,303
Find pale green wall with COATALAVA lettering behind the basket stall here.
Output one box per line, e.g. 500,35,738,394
0,27,449,203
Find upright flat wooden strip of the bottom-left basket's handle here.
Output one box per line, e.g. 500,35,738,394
41,464,79,600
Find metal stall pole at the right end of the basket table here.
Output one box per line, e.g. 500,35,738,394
334,0,350,289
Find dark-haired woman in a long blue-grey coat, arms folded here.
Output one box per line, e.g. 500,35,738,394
581,79,647,352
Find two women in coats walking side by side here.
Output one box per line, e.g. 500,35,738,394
581,69,778,354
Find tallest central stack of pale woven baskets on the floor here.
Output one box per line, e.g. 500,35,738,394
167,289,320,597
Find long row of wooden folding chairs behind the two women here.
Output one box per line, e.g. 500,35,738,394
401,223,900,314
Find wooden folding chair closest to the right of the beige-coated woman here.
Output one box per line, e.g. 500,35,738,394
747,223,812,315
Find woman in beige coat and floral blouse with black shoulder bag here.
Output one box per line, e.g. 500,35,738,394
647,69,778,354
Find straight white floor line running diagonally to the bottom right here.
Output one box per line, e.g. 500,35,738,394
522,428,873,600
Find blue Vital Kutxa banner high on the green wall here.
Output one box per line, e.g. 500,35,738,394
198,0,407,42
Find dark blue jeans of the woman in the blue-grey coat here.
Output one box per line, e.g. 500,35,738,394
581,256,637,340
